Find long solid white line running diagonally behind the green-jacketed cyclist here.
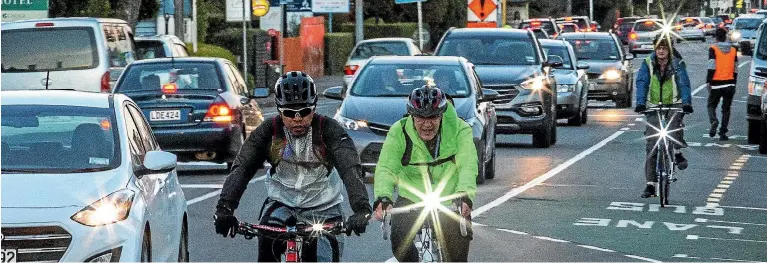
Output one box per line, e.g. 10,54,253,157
471,131,625,217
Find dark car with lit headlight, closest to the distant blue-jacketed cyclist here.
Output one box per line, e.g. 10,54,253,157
560,33,634,108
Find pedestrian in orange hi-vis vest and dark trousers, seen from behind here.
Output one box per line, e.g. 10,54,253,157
706,28,738,141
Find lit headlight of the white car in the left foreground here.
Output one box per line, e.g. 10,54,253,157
71,189,135,226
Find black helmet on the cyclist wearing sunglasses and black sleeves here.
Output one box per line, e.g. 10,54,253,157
274,71,317,107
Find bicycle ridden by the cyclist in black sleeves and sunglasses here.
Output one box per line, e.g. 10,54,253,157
237,219,346,262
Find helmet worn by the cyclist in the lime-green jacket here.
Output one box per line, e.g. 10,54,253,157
407,85,447,118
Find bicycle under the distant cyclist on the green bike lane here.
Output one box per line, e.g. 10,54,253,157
644,106,685,207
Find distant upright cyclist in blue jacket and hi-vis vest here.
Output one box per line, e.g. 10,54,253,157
634,34,693,198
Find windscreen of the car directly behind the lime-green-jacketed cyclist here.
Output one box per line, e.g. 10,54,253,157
351,64,470,98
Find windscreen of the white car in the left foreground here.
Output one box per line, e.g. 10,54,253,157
0,105,120,173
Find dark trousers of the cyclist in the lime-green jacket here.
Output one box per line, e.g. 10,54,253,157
390,197,472,262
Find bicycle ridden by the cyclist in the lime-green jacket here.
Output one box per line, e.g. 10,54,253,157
381,201,468,262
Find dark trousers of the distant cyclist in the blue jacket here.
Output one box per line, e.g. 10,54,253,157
644,111,687,182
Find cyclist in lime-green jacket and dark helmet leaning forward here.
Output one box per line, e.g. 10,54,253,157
373,85,478,262
